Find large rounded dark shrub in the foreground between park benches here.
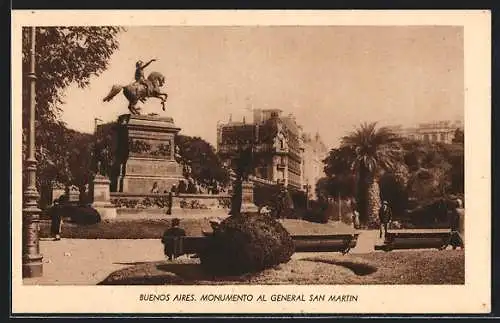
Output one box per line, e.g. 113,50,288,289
200,214,295,275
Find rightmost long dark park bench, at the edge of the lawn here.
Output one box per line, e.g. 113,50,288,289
375,229,451,251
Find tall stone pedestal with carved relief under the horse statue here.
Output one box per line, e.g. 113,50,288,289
111,114,183,194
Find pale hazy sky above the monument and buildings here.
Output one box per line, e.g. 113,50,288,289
61,26,464,148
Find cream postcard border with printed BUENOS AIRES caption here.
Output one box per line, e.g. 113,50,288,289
12,10,491,314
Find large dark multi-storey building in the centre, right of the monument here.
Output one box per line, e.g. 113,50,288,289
217,109,304,190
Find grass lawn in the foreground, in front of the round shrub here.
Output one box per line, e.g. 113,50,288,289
99,250,465,285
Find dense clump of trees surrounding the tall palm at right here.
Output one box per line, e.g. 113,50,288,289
318,124,464,221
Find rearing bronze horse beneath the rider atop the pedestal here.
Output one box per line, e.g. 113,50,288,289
103,72,168,115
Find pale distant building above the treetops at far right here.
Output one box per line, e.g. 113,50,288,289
388,120,464,143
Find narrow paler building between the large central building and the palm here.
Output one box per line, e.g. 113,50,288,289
302,133,328,199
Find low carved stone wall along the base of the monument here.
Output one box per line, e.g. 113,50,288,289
111,192,231,217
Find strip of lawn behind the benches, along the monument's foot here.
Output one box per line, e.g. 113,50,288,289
40,218,353,239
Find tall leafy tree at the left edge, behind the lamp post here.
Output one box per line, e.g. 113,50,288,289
22,27,123,192
